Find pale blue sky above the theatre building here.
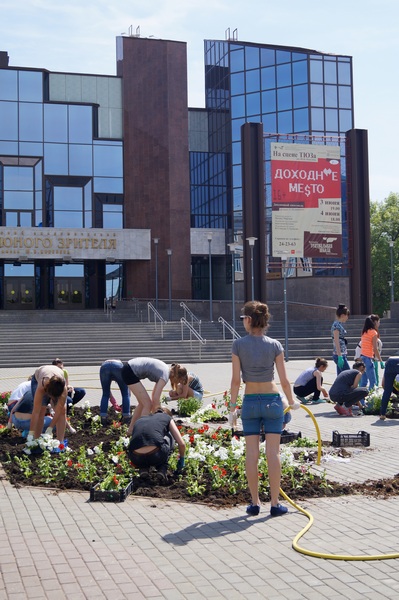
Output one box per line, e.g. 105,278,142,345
0,0,399,201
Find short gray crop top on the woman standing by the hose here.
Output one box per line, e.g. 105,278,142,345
232,335,284,383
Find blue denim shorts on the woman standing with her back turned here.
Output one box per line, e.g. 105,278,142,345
241,394,284,436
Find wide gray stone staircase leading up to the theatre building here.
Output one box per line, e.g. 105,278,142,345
0,307,399,368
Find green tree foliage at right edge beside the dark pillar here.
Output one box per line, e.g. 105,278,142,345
370,193,399,315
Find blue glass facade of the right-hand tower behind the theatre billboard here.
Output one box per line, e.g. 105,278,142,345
205,40,354,275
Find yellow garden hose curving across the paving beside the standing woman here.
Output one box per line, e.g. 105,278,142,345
280,404,399,560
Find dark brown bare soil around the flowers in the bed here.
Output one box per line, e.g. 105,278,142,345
0,408,399,508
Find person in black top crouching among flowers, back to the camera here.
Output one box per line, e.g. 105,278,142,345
128,408,186,482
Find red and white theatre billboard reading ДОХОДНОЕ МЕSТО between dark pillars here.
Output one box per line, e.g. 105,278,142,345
270,142,342,258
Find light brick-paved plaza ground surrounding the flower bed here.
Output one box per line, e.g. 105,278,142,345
0,361,399,600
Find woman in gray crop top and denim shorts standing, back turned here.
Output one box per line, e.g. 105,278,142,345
230,301,300,517
